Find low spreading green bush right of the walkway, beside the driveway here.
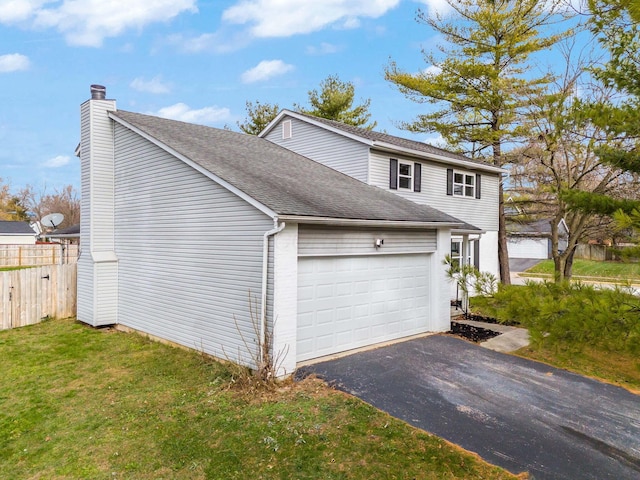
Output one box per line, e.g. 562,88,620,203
474,282,640,353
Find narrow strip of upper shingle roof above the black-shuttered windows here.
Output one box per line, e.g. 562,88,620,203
285,111,494,167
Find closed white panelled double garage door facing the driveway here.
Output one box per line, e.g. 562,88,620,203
297,254,430,361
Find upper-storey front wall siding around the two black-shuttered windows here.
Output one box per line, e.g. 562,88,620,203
369,151,500,231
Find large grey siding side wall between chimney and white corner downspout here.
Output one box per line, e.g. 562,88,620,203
115,125,273,366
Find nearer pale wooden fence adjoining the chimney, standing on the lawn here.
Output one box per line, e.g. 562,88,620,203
0,263,78,330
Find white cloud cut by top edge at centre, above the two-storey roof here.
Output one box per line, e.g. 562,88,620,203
222,0,400,37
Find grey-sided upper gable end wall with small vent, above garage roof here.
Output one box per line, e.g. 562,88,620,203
265,117,369,182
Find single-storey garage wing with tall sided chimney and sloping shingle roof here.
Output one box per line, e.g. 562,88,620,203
78,86,464,373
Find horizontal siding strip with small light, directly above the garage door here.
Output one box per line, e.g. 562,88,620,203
298,225,436,256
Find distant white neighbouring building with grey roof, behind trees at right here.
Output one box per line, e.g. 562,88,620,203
507,219,569,259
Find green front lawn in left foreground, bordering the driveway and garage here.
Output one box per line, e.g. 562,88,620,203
0,320,515,480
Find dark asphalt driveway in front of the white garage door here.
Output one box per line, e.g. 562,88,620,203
299,335,640,480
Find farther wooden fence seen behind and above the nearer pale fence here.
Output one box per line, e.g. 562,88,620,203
0,243,78,267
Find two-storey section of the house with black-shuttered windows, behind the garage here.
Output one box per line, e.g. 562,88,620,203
260,110,504,277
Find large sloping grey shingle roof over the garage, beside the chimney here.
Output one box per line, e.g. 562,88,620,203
112,110,462,224
